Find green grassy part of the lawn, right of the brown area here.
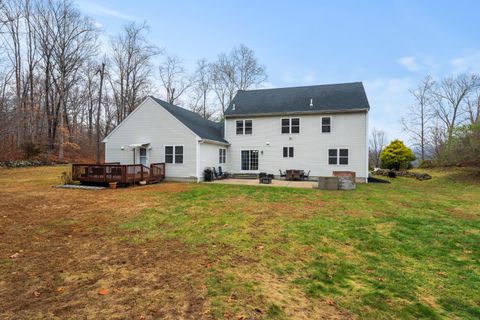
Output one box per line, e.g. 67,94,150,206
119,169,480,319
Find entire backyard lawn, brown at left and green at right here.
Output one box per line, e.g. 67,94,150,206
0,167,480,319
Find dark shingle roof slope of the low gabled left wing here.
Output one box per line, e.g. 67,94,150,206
151,97,228,143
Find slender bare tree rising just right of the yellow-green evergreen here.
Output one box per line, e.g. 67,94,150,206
401,76,435,161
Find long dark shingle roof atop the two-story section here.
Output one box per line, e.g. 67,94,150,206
225,82,370,117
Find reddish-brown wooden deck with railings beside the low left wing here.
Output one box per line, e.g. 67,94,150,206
72,163,165,185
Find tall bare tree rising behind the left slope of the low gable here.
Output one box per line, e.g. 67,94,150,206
108,22,160,123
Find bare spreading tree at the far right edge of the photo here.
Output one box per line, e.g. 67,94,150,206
435,74,480,139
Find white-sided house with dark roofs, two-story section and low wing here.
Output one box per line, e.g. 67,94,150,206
103,82,370,182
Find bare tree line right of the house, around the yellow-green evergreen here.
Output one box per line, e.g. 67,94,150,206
369,73,480,167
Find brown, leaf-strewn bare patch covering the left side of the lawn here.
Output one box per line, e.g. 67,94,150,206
0,168,211,319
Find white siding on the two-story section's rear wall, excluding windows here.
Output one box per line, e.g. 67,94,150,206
225,112,368,180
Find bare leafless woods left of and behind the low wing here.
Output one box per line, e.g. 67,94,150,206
0,0,267,161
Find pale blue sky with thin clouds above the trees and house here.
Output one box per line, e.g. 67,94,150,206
77,0,480,142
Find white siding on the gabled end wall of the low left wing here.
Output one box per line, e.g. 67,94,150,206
105,98,198,178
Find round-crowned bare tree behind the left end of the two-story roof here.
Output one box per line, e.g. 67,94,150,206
212,44,267,114
